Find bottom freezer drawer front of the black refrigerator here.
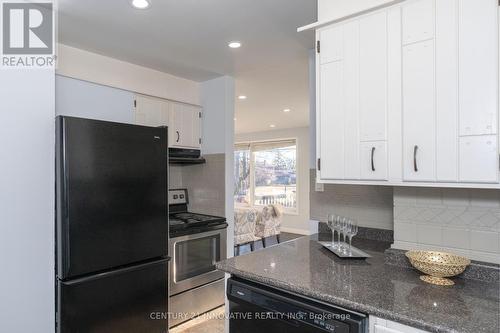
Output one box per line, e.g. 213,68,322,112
56,260,168,333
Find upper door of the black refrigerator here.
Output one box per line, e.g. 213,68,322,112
56,117,168,280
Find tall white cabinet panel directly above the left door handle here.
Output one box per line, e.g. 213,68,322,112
359,11,387,141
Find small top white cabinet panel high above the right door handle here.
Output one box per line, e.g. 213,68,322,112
402,0,434,44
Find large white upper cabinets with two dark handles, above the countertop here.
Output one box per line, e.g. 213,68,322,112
316,0,500,188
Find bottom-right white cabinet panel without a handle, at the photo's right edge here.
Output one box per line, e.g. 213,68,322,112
460,135,498,183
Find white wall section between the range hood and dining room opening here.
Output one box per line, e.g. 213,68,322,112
201,76,235,257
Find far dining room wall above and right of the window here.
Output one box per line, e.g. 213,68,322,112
236,127,310,234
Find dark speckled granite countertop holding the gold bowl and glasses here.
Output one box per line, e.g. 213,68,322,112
217,235,500,333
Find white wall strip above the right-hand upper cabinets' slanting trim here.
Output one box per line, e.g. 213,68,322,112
318,0,395,22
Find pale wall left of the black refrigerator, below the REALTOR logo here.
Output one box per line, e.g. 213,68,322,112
0,69,55,333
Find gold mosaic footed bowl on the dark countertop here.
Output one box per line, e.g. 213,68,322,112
406,251,470,286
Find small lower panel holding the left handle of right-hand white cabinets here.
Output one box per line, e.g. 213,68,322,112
360,141,387,180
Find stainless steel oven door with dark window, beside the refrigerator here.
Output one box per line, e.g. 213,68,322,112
169,229,227,296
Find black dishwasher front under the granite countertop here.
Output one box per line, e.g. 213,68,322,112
227,278,368,333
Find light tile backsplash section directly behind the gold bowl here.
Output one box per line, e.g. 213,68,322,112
393,187,500,263
